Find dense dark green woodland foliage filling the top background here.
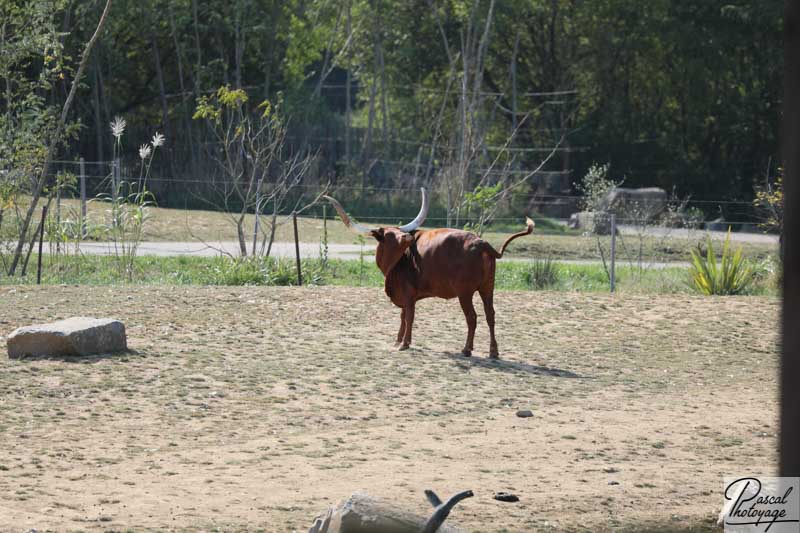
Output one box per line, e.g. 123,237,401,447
0,0,782,214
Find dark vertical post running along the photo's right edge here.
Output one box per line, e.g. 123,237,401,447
780,0,800,477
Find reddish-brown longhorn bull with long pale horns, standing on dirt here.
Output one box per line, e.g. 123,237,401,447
325,189,533,358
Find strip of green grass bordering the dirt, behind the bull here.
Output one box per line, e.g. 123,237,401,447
0,250,777,295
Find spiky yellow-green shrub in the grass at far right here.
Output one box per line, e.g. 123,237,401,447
689,229,756,296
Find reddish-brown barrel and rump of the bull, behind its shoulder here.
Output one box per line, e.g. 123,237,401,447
417,229,495,298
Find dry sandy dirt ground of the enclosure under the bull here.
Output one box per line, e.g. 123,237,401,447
0,287,779,531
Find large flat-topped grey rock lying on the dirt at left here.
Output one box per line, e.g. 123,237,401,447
7,317,128,358
